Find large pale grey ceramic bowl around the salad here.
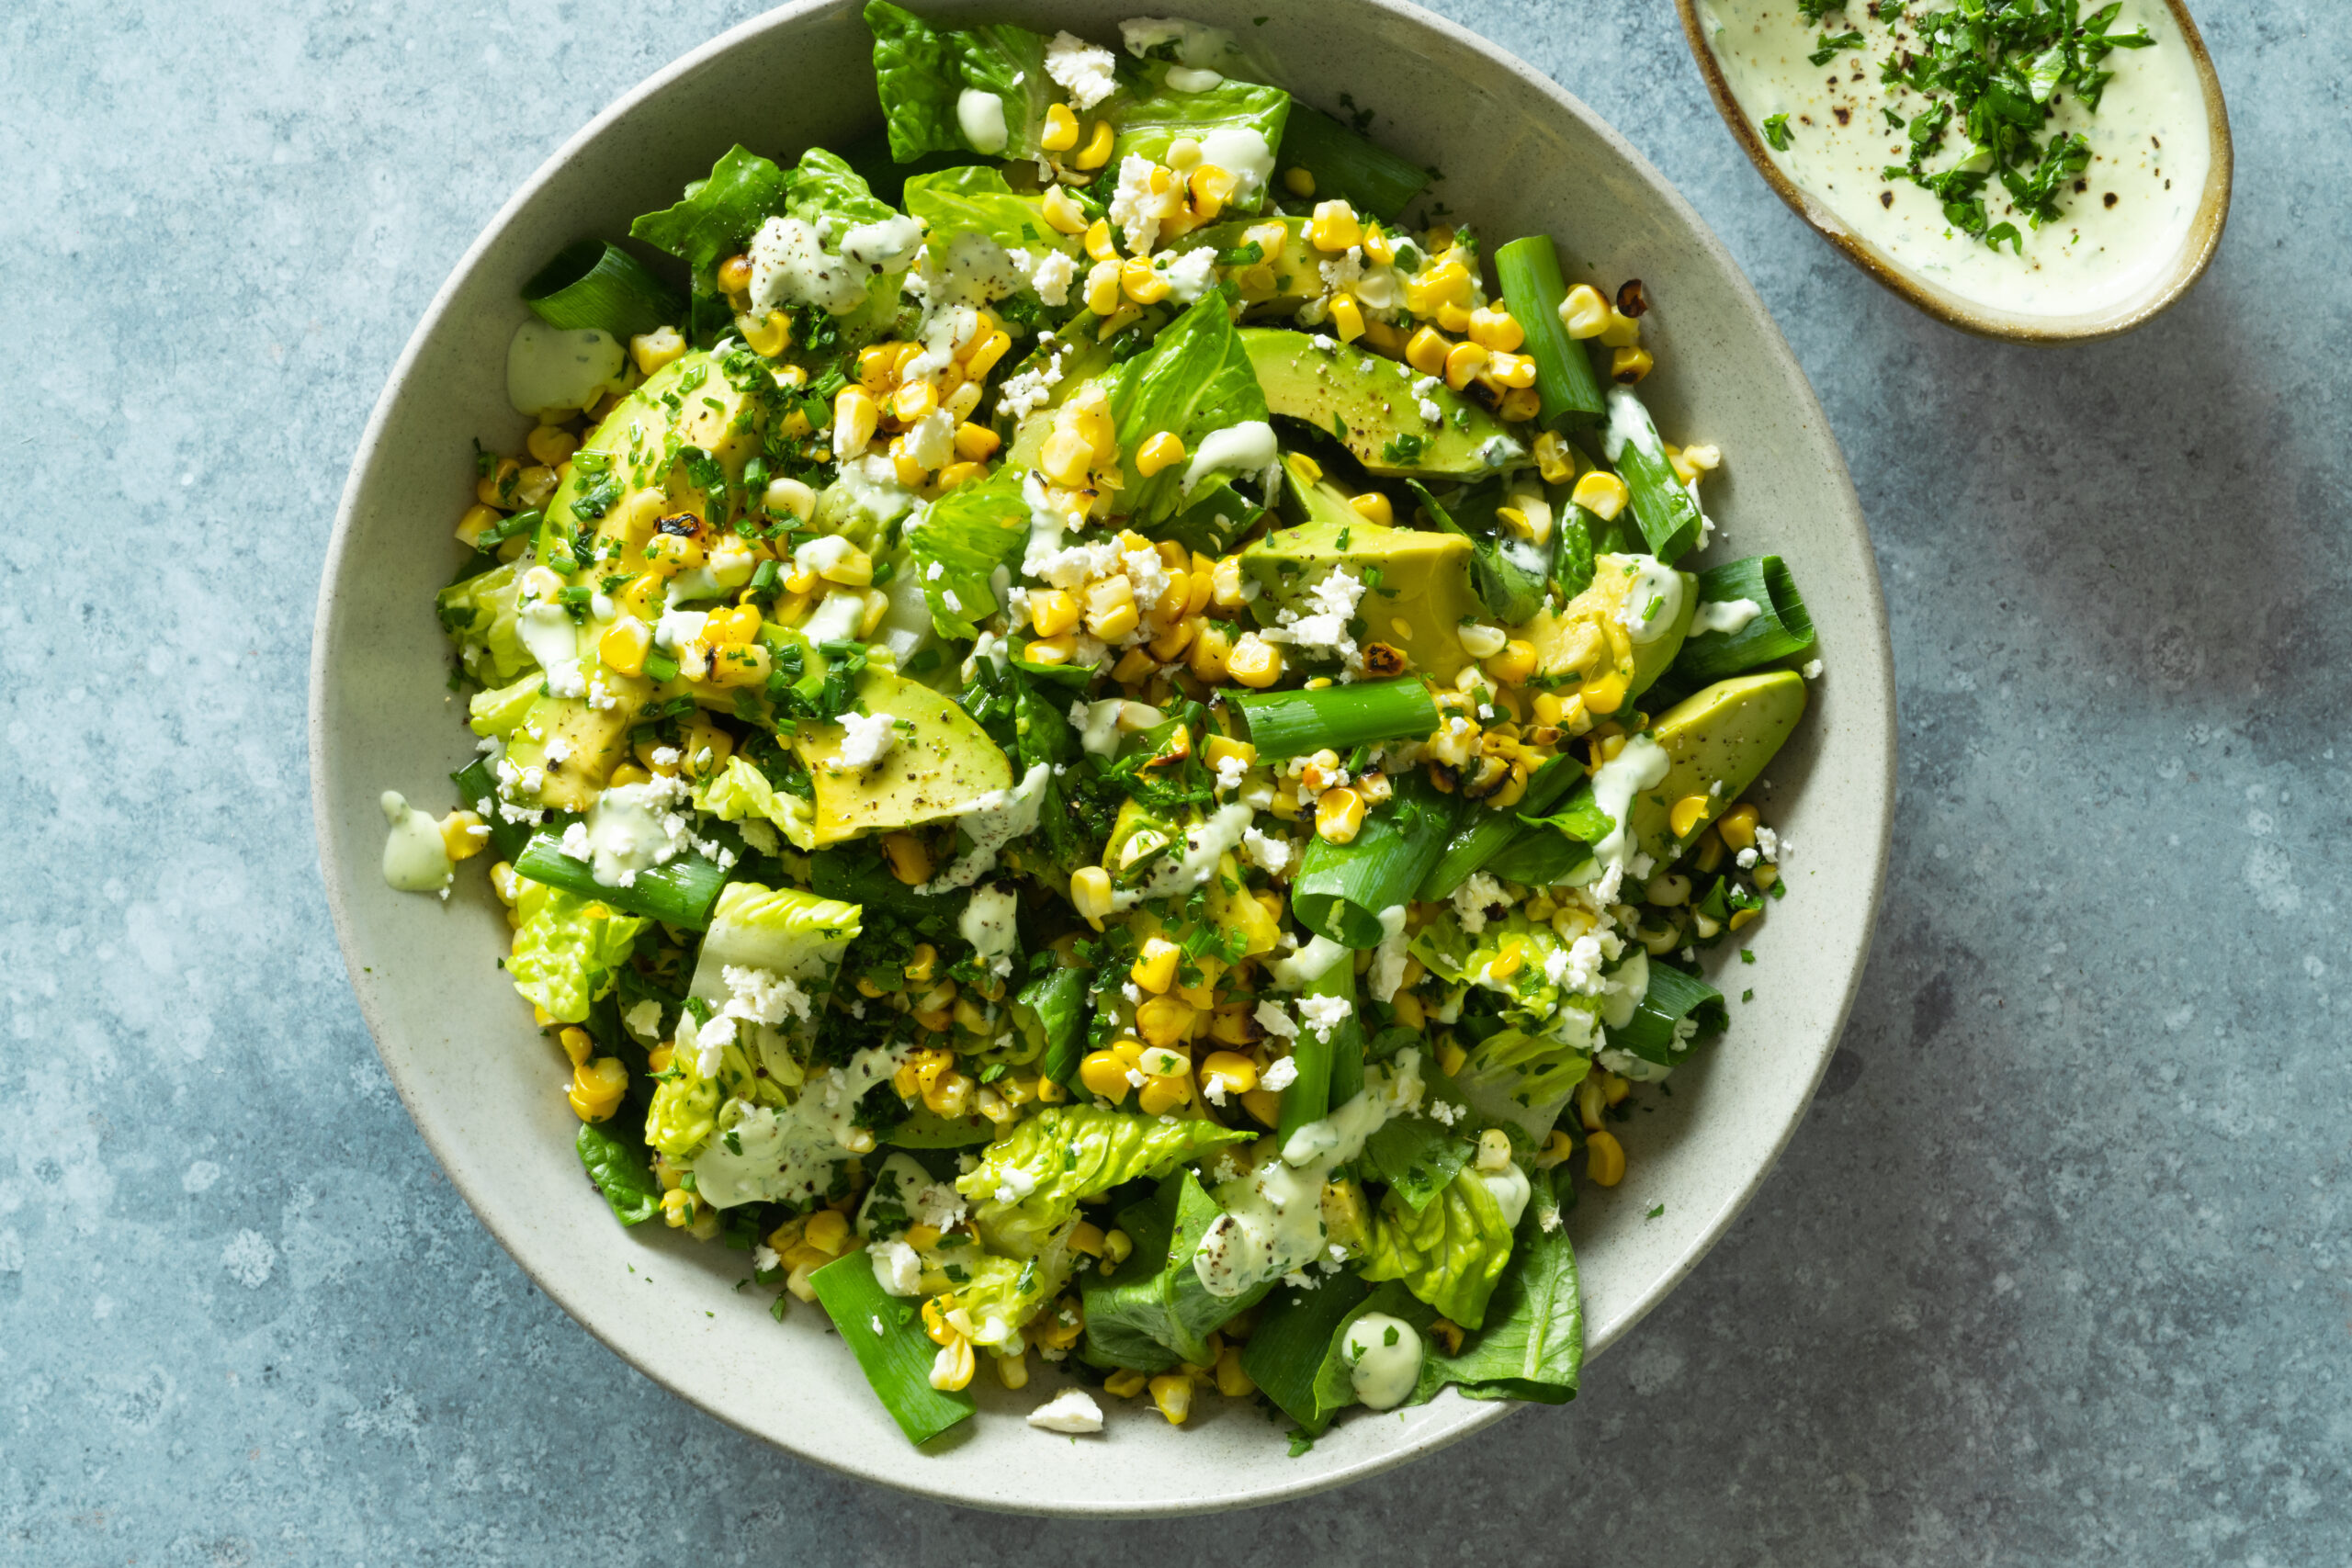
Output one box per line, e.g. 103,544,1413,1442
311,0,1894,1514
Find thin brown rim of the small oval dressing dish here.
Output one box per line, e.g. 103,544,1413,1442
1675,0,2237,348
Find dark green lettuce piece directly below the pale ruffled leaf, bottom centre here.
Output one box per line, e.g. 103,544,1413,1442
1082,1170,1275,1373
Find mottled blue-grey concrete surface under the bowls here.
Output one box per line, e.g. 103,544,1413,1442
0,0,2352,1568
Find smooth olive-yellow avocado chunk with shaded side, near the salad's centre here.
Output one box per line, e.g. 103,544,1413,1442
1242,517,1484,682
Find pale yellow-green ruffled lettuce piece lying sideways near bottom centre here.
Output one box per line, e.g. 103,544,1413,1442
955,1105,1253,1258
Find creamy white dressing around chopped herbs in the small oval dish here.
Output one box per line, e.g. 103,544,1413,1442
1701,0,2213,315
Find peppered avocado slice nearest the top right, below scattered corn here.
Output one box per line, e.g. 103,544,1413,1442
1242,327,1526,479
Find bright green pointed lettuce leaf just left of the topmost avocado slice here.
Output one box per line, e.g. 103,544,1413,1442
1105,291,1265,534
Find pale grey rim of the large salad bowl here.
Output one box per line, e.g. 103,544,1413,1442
306,0,1898,1518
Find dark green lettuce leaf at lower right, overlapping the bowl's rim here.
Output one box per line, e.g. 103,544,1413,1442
1414,1176,1585,1405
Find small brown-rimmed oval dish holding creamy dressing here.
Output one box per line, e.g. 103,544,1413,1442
1675,0,2232,344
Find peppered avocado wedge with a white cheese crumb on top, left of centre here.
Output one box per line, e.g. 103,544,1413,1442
793,670,1013,849
